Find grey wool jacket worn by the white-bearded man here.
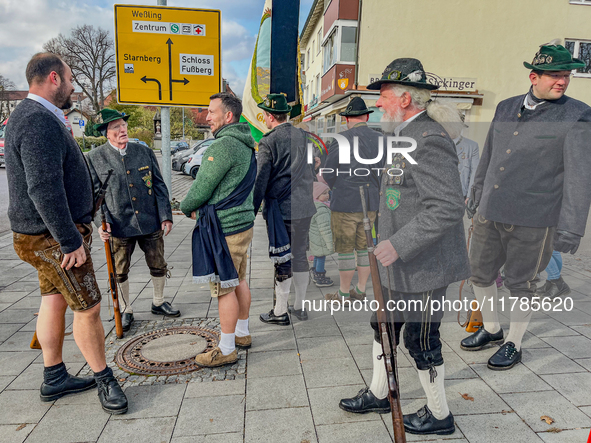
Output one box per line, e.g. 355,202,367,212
378,113,470,292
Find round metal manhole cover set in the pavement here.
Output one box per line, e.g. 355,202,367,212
115,326,219,376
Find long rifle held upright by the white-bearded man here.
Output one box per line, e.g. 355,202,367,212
359,186,406,443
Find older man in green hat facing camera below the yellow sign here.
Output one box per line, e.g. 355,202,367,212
88,108,181,331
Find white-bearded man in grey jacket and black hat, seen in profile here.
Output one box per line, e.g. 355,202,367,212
339,58,470,435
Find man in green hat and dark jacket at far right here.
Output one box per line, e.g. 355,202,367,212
461,40,591,370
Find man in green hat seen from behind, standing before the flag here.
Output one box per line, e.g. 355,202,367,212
254,94,316,325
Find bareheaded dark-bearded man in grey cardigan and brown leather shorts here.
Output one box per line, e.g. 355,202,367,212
6,53,127,414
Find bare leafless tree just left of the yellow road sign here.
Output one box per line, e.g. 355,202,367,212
43,25,115,115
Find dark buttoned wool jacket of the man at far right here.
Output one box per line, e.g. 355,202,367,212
474,95,591,236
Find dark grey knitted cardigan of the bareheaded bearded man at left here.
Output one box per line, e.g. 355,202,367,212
5,98,93,254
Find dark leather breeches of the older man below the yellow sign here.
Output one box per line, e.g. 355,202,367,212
111,231,168,283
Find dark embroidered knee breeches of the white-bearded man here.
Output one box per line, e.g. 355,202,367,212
370,286,447,370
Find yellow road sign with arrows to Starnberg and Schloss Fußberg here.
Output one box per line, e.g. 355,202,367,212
115,5,222,107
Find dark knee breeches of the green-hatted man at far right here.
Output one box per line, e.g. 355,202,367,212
470,213,556,297
